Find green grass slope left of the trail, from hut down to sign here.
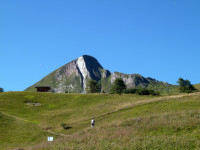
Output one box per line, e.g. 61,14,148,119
0,92,151,148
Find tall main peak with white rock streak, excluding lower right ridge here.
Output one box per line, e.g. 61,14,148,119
26,55,109,93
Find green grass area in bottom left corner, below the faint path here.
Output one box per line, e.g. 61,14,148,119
0,112,54,148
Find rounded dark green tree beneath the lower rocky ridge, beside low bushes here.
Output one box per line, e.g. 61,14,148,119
111,78,126,94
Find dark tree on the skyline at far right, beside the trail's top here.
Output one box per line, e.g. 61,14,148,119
177,78,196,93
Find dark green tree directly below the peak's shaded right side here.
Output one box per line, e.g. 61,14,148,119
86,79,101,93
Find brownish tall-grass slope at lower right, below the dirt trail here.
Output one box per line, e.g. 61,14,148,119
36,92,200,150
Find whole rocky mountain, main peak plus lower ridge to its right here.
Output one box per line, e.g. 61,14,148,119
26,55,172,93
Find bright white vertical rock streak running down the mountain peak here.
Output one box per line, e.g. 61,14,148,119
77,56,91,91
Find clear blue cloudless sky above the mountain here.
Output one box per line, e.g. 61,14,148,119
0,0,200,91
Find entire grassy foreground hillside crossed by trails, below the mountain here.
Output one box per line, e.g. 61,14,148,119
0,92,200,149
